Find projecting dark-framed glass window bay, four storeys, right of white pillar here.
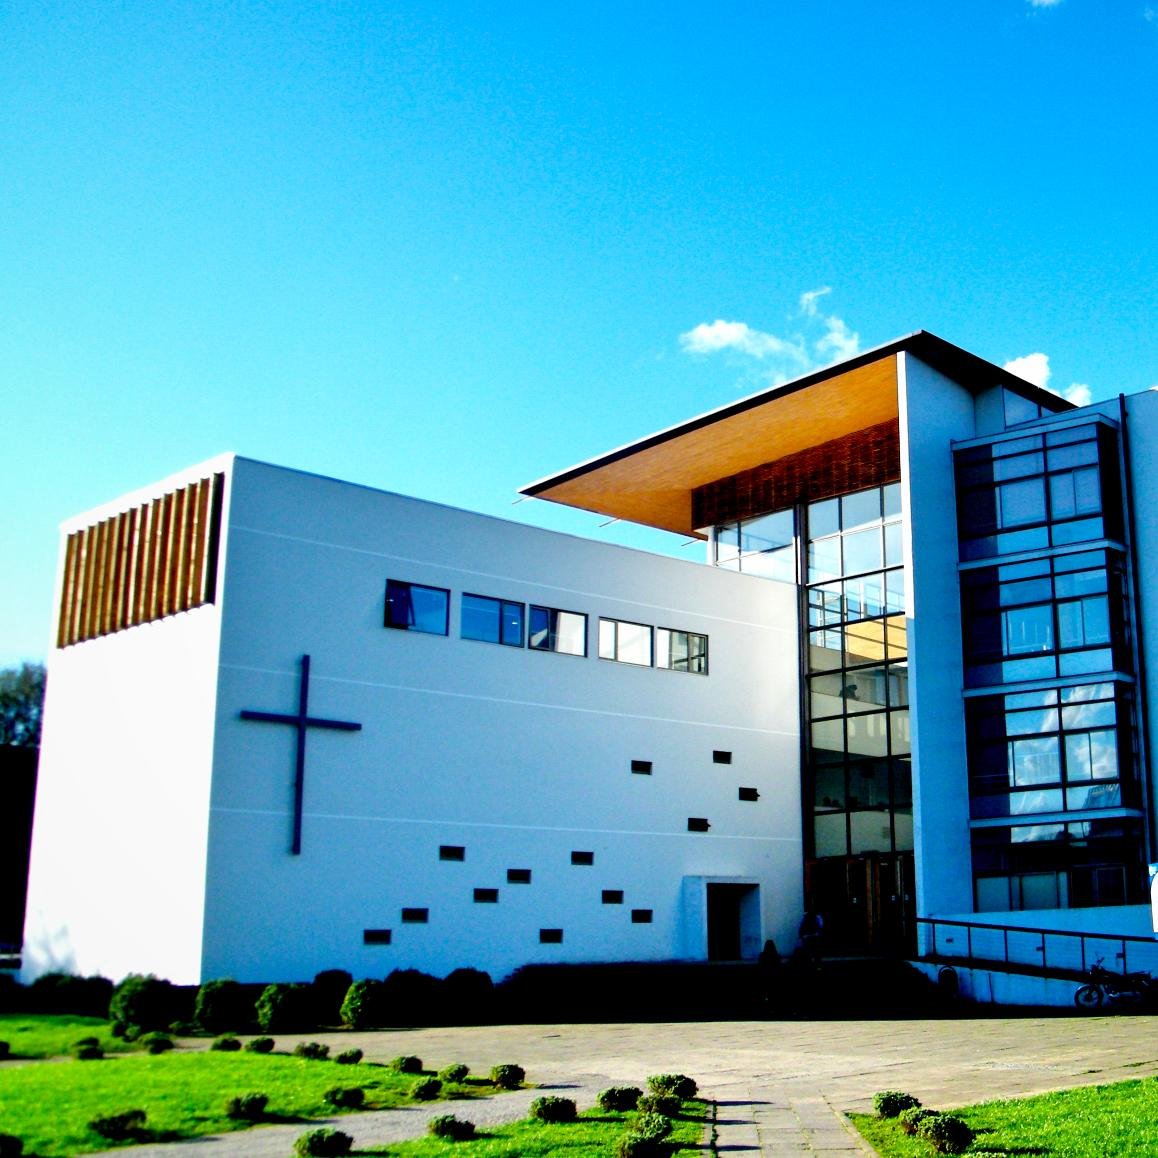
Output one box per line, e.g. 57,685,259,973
955,423,1145,911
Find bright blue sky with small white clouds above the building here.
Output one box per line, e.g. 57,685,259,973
0,0,1158,665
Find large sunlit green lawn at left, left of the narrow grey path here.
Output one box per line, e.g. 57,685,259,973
0,1056,479,1158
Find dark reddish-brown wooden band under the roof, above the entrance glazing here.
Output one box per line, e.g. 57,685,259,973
691,418,901,527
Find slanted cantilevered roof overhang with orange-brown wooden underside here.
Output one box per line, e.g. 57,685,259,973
520,330,1069,535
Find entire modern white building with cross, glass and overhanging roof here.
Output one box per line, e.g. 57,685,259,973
24,332,1158,999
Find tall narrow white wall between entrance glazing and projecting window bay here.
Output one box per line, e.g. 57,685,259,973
897,353,975,916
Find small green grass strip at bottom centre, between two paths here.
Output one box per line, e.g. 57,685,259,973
357,1101,709,1158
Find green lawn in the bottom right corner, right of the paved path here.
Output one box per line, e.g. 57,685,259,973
851,1078,1158,1158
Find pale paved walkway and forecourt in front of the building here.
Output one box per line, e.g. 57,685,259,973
92,1017,1158,1158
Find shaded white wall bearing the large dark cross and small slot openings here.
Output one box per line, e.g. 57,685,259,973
203,460,801,980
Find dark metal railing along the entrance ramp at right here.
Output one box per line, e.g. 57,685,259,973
916,917,1158,974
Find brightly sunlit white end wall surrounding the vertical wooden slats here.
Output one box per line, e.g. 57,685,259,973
23,459,228,982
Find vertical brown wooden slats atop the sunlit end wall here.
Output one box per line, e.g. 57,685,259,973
57,475,225,647
